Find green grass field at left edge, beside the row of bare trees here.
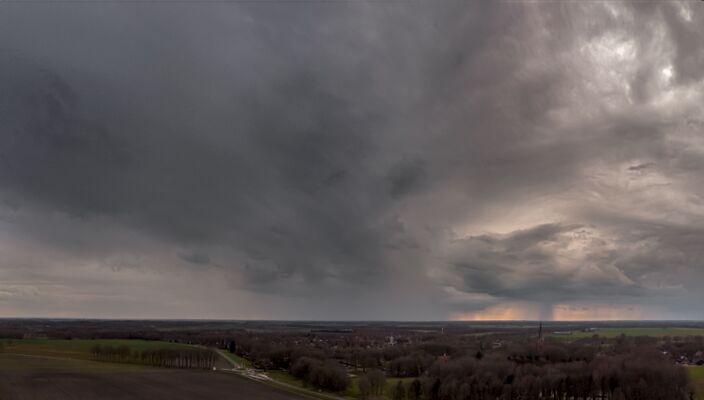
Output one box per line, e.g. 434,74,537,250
4,339,192,360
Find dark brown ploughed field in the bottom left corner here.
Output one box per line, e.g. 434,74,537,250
0,354,303,400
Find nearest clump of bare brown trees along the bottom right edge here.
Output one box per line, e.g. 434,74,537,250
359,348,694,400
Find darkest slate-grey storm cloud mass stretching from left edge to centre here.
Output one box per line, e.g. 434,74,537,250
2,54,396,286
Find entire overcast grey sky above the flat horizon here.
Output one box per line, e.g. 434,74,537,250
0,1,704,320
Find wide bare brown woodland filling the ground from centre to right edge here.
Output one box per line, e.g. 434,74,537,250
230,335,699,400
